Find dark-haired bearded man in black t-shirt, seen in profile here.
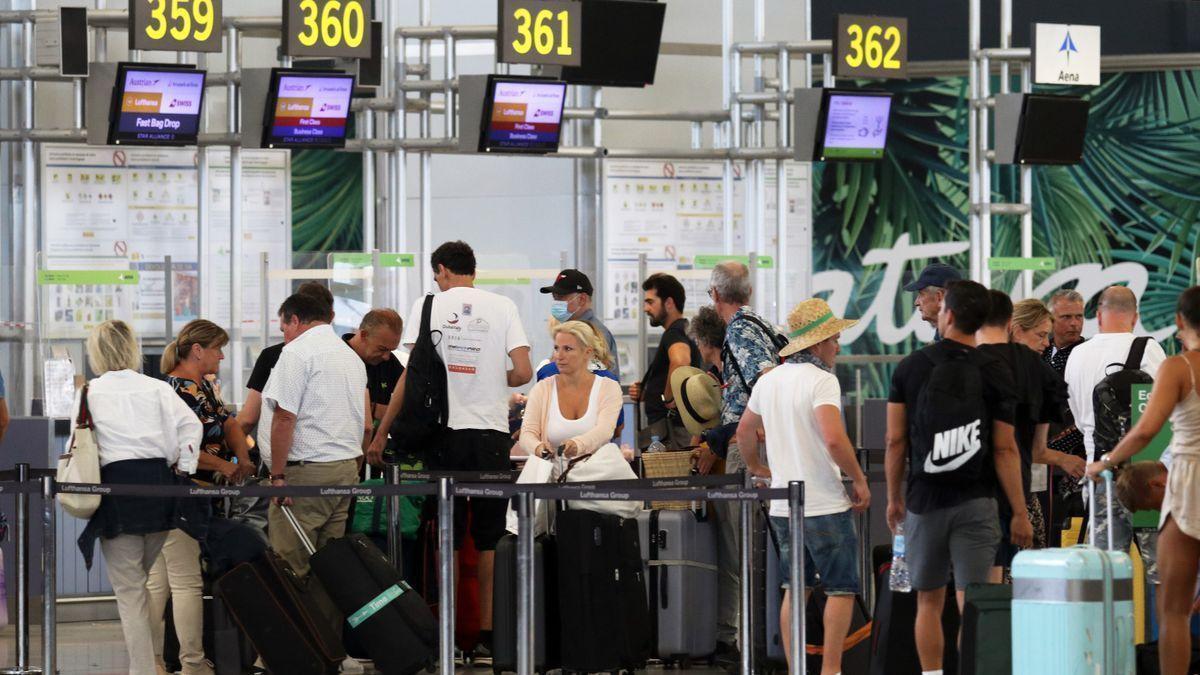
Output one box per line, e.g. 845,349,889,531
629,274,701,449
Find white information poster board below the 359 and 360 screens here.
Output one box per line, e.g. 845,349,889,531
40,144,292,339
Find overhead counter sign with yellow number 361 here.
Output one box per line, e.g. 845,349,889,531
496,0,583,66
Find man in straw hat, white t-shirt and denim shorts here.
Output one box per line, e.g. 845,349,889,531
738,298,871,675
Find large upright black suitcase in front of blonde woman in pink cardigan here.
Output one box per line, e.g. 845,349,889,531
556,510,650,673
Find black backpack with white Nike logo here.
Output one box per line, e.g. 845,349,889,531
910,348,991,484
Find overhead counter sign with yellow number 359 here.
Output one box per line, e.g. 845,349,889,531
130,0,222,52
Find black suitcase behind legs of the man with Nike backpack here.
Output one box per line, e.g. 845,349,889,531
871,546,960,675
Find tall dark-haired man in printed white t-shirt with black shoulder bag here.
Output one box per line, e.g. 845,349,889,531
367,241,533,658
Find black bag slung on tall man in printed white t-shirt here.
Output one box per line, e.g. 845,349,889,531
389,293,450,459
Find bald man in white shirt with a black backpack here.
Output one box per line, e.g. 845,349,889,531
1063,286,1166,557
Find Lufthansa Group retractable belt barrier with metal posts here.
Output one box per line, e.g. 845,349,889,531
7,465,805,675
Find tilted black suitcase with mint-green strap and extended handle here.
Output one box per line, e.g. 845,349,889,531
281,507,438,675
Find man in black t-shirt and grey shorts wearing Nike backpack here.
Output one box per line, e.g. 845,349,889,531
886,281,1032,671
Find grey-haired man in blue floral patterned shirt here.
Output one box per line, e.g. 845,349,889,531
700,261,787,667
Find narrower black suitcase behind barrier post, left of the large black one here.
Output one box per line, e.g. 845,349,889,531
492,534,559,674
